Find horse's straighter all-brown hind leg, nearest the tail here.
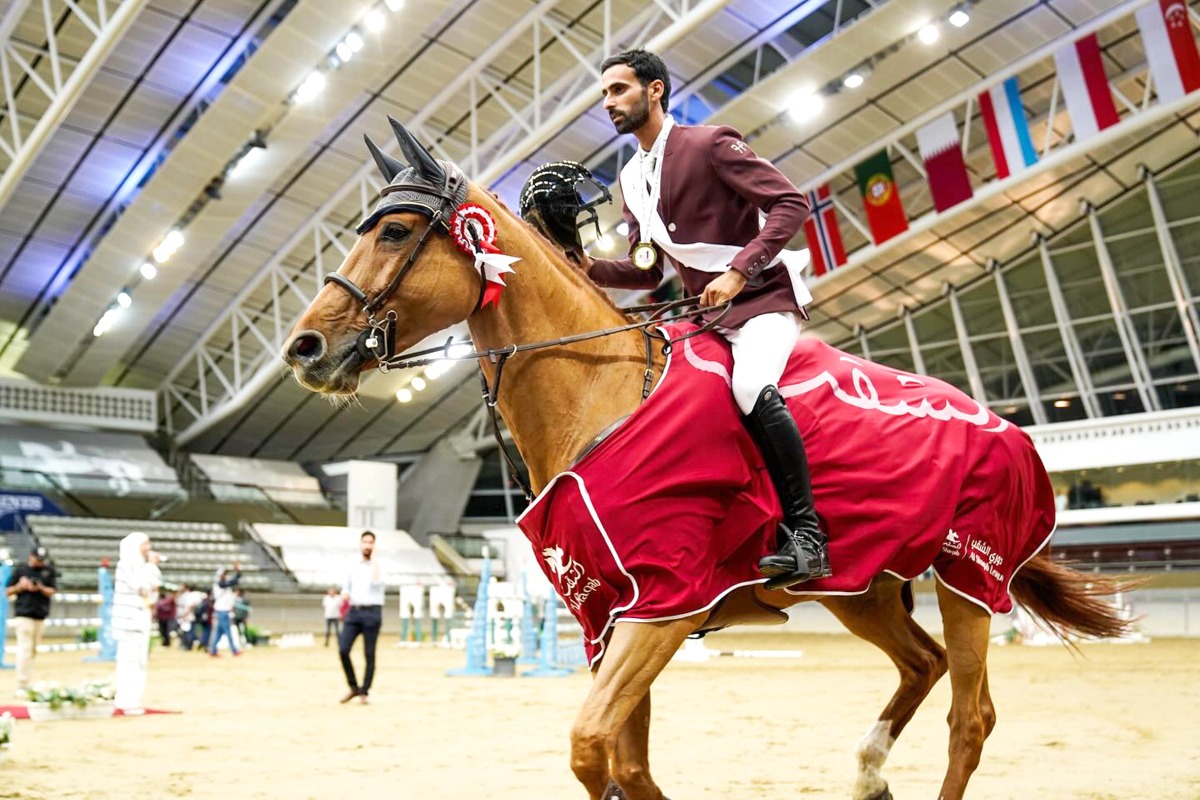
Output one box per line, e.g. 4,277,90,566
937,583,996,800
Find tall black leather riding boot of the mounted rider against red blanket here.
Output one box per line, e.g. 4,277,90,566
746,386,833,589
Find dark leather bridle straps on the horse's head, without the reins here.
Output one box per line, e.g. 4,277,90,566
323,169,487,372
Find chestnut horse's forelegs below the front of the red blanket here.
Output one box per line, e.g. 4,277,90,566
571,616,702,800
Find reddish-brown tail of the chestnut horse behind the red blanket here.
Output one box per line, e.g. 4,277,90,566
1010,551,1140,643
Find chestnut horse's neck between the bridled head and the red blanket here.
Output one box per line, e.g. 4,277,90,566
468,211,646,491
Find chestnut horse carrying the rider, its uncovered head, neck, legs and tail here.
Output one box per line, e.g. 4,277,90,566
283,120,1124,800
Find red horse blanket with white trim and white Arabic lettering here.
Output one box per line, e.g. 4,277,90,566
517,325,1055,663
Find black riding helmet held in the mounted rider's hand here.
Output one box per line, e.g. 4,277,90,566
520,161,612,251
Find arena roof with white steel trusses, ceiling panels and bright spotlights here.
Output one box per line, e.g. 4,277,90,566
0,0,1200,462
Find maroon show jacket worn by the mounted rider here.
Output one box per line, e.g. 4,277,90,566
588,125,810,327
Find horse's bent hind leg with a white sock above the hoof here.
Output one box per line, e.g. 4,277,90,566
821,581,946,800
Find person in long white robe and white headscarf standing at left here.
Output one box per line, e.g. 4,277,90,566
113,531,162,715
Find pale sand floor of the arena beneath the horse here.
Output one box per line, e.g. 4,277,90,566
0,634,1200,800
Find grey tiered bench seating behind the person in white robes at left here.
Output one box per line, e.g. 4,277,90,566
26,516,295,591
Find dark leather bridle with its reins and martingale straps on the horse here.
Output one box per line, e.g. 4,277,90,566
323,170,731,503
